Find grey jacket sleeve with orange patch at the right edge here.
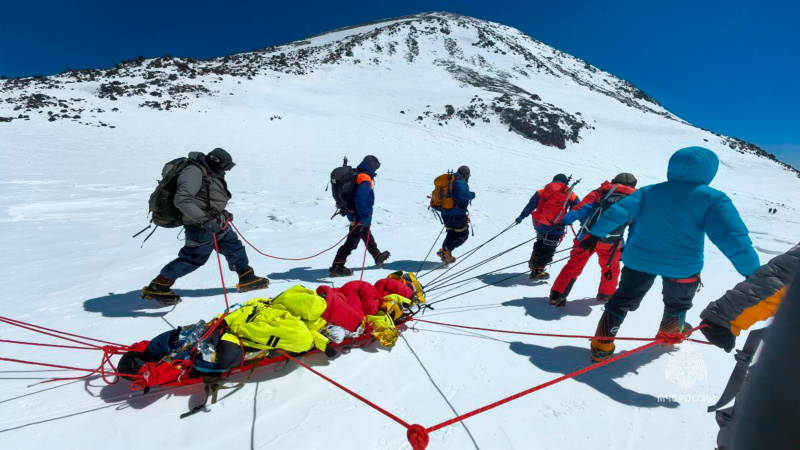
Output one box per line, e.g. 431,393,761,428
700,244,800,336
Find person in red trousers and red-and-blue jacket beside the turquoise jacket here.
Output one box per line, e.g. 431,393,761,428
550,173,636,307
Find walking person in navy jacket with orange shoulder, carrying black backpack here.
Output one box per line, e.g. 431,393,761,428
328,155,390,277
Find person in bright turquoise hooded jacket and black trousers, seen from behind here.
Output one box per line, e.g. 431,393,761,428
581,147,760,361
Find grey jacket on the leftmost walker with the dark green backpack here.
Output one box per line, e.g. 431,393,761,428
174,152,232,225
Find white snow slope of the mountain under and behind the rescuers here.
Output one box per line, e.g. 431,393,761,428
0,13,800,450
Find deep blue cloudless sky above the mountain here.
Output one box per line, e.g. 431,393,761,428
0,0,800,167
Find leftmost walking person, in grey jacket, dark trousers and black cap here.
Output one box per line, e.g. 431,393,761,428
142,148,269,304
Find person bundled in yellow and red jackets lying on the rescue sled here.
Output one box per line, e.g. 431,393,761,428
117,272,424,387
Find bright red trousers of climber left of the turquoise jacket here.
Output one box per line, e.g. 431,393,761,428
552,239,622,297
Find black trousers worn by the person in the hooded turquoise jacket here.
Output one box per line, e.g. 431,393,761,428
596,267,700,338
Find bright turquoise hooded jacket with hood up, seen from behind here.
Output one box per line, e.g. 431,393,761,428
591,147,760,278
